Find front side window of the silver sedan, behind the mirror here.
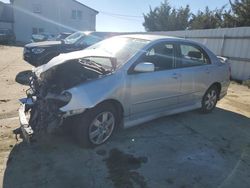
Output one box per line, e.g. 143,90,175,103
140,42,174,71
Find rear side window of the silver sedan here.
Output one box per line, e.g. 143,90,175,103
179,44,210,67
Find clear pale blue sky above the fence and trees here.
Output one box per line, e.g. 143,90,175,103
2,0,229,32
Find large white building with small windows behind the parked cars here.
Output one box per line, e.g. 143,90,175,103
12,0,98,42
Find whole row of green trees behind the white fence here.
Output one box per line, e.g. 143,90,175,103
143,0,250,31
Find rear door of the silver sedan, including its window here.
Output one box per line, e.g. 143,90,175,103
176,43,212,106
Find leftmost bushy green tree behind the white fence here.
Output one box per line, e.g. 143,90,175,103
143,0,191,31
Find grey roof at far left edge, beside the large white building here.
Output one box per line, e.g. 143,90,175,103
0,1,14,23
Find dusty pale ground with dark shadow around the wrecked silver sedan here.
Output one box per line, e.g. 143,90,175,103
0,46,250,188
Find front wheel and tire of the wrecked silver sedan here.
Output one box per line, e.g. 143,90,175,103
74,103,118,147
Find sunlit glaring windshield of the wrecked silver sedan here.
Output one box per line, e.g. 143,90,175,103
87,37,149,67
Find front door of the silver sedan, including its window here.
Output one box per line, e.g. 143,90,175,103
128,42,180,118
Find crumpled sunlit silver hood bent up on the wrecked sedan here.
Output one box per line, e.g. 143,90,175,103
33,49,114,77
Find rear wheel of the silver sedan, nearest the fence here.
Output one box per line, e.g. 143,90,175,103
201,86,218,113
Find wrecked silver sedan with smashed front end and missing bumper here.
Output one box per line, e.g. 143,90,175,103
19,35,230,146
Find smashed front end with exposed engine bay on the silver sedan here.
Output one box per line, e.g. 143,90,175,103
19,58,112,142
